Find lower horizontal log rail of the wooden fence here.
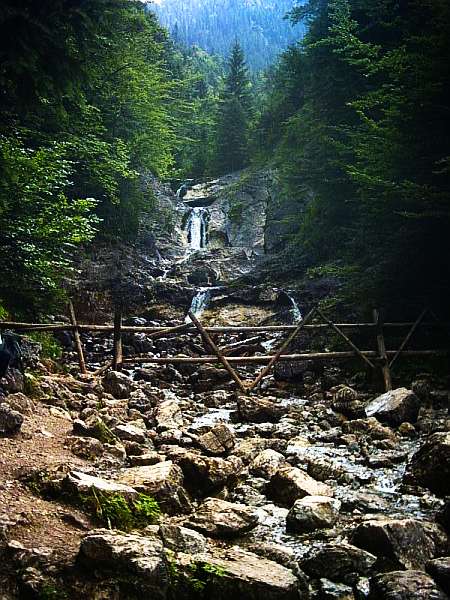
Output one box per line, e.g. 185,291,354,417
123,350,448,365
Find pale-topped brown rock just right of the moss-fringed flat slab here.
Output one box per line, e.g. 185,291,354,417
118,461,191,514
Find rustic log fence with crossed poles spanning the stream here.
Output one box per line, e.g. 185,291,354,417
0,302,449,393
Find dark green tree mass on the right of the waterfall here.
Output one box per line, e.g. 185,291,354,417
255,0,450,309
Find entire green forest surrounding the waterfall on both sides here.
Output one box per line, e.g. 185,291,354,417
0,0,450,311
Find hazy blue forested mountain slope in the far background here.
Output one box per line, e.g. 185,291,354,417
148,0,303,70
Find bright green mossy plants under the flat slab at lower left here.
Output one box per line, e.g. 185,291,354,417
80,488,161,531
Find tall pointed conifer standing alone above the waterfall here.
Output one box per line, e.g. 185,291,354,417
214,41,251,174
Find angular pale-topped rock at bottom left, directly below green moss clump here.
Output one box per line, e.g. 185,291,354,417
78,529,170,600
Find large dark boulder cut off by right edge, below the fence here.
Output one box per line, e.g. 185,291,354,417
405,431,450,496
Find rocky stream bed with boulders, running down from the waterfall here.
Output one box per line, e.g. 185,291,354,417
0,171,450,600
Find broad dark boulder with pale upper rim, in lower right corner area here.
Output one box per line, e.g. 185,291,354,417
351,519,445,569
